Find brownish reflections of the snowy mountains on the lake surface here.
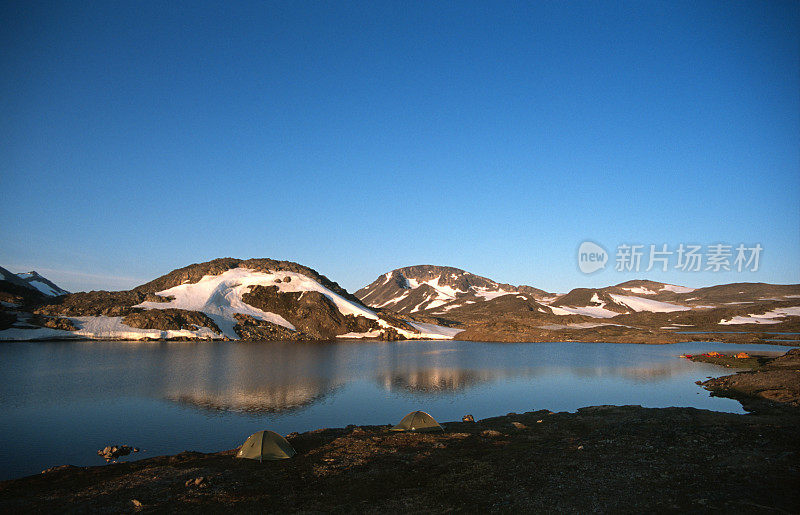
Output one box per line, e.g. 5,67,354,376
142,342,780,414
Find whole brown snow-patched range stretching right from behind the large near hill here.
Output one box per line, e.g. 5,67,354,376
356,265,800,343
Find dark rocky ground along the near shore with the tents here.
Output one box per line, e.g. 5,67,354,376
0,350,800,513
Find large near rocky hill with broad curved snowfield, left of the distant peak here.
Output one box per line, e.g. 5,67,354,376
0,258,459,340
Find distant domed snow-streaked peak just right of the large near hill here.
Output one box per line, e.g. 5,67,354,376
356,265,550,314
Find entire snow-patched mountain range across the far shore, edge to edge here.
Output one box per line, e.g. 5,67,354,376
0,258,800,344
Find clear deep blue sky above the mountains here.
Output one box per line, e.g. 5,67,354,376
0,1,800,291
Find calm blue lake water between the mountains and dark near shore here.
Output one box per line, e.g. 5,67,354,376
0,341,788,479
